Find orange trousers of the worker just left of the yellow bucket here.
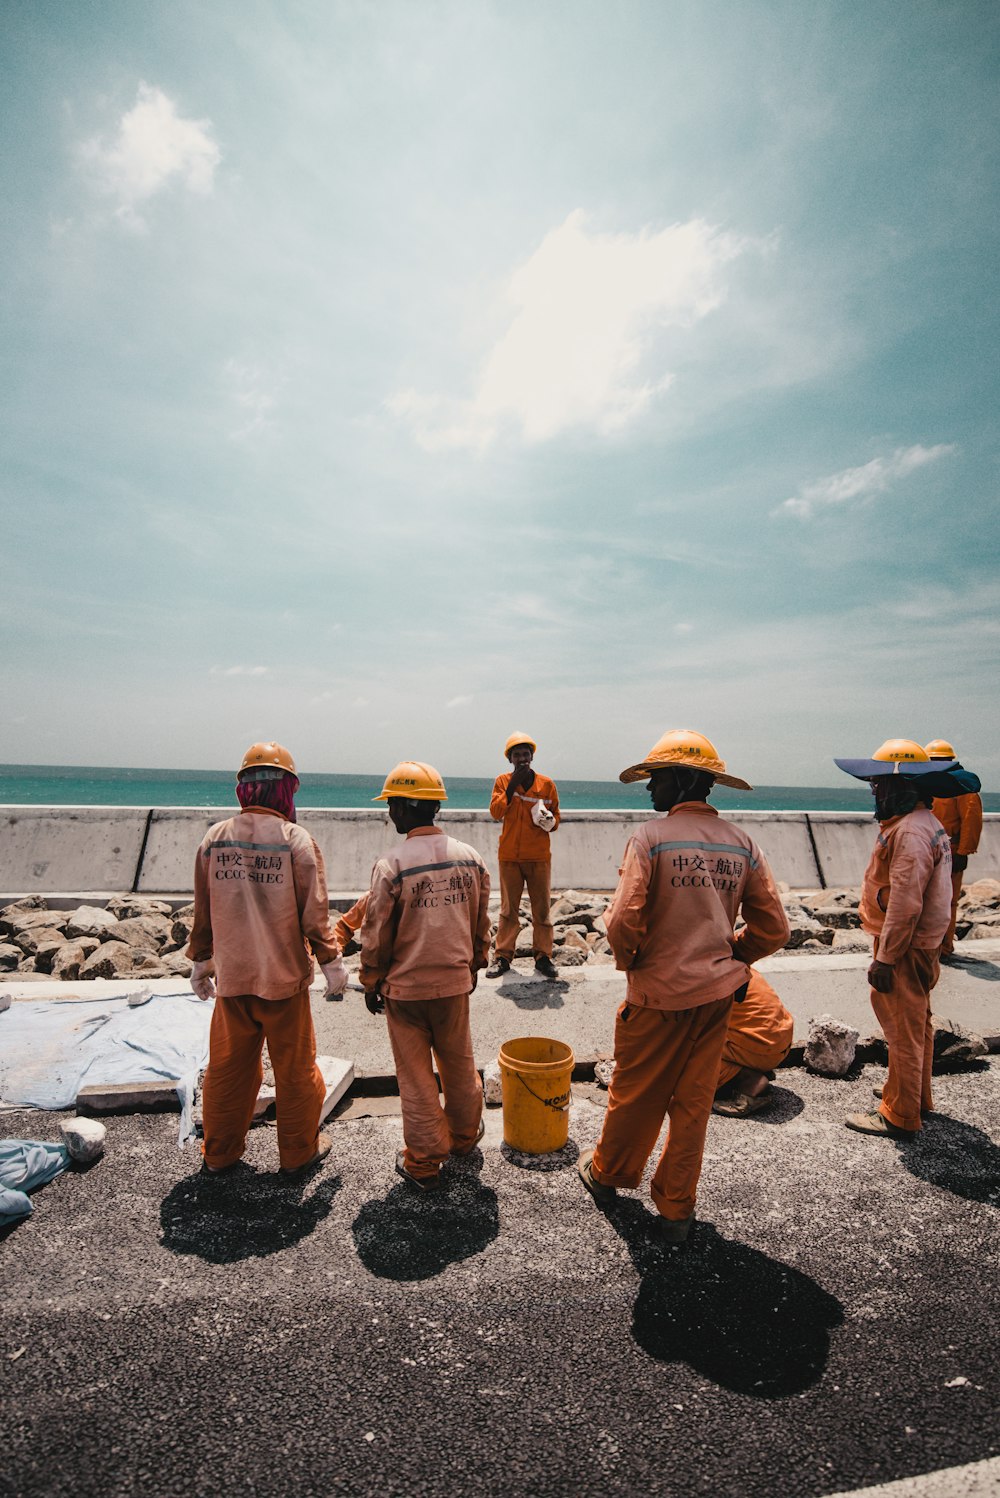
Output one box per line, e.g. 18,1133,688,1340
385,993,482,1176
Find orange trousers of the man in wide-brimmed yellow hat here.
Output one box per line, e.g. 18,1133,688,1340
591,995,732,1222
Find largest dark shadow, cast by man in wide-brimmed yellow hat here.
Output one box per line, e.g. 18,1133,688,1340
606,1201,844,1399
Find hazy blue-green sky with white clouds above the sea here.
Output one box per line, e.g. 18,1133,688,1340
0,0,1000,786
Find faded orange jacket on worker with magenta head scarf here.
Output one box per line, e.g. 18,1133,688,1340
187,806,340,999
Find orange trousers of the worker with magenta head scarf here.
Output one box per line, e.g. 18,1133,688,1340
202,989,326,1170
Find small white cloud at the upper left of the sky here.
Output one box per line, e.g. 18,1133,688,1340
81,82,220,229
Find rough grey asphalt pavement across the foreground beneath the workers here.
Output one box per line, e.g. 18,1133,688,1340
0,1058,1000,1498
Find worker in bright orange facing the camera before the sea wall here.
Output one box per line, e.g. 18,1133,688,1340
487,734,560,978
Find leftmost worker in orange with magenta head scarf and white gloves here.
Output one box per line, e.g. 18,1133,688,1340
187,743,347,1177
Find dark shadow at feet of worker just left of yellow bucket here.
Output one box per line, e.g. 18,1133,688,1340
350,1149,500,1281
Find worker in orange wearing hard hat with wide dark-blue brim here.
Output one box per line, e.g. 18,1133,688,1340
834,739,979,1138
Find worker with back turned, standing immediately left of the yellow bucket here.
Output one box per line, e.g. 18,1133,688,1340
361,761,490,1191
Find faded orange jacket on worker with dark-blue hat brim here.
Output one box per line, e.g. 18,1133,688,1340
858,806,952,963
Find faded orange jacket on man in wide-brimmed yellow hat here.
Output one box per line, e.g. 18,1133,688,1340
605,801,789,1010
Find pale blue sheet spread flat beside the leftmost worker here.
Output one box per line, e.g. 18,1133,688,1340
0,992,213,1144
